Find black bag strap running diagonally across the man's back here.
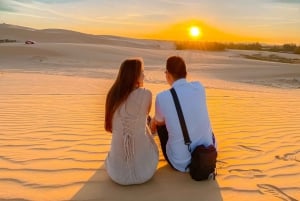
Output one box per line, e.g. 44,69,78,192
170,88,192,152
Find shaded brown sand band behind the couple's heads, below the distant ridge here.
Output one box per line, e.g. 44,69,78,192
0,43,300,89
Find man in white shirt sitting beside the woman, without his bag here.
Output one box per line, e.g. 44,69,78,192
150,56,215,172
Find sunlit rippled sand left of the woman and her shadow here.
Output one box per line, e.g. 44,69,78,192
0,74,110,200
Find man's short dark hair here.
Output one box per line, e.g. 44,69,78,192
166,56,187,80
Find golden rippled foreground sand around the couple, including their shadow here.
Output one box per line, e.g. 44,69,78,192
0,72,300,201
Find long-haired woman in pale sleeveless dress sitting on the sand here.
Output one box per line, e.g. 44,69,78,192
105,59,158,185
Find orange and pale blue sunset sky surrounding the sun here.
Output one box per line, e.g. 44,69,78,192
0,0,300,44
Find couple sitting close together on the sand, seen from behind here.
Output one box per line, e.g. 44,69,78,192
105,56,217,185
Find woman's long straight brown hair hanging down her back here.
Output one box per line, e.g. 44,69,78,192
105,59,142,132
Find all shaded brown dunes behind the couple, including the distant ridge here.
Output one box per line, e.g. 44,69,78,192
0,24,300,89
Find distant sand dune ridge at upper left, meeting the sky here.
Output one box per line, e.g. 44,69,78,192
0,24,174,49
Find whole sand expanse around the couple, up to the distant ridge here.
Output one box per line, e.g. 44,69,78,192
0,24,300,201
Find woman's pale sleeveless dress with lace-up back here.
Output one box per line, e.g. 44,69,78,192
105,88,158,185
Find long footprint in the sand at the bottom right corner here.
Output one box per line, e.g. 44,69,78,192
257,184,298,201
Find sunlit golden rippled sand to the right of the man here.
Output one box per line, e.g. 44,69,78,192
208,89,300,200
